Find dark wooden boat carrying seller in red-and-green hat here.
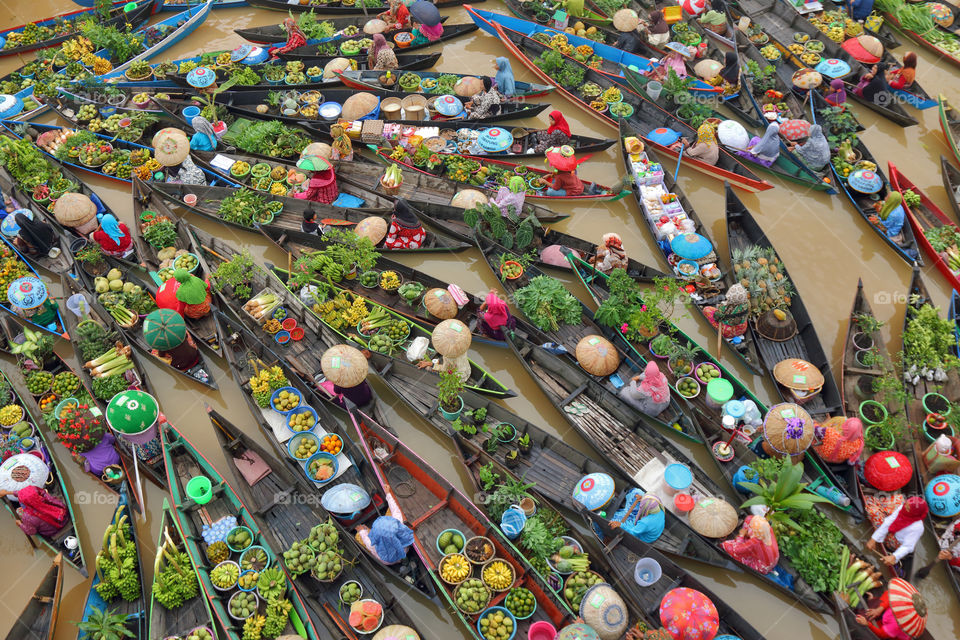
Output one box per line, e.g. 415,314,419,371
131,178,221,355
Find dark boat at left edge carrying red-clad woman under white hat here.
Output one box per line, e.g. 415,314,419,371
0,364,87,576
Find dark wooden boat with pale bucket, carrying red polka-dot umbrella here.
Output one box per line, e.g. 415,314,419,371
581,509,767,640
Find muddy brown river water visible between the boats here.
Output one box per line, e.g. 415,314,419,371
0,0,960,640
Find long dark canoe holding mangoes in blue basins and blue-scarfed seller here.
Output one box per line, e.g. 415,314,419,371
211,312,437,599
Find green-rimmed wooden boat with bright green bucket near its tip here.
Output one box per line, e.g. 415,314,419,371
160,422,320,640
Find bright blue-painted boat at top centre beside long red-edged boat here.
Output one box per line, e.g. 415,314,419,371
463,4,720,94
